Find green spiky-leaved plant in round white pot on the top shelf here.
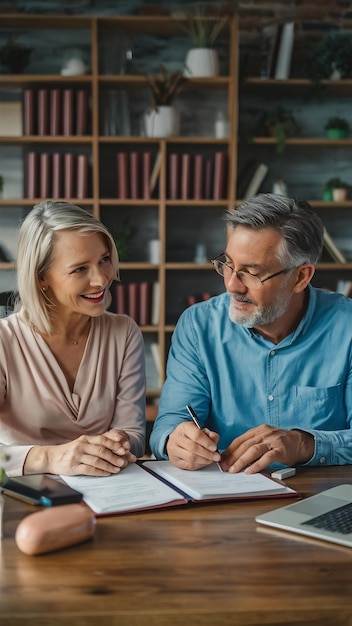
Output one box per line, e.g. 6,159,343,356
181,5,228,77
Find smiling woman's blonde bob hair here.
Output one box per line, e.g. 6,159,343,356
17,201,119,334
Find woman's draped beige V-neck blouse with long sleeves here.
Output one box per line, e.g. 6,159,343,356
0,312,146,476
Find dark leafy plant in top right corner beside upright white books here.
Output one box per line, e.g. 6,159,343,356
306,31,352,83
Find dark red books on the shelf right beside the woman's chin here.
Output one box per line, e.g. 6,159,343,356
115,281,160,326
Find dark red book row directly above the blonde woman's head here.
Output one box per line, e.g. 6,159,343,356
24,152,88,199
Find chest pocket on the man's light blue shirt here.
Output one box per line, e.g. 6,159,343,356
293,384,346,430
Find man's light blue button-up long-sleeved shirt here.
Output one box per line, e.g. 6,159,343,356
150,286,352,466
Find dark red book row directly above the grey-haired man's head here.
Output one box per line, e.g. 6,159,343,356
167,151,228,200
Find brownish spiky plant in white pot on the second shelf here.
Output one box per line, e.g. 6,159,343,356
144,64,187,137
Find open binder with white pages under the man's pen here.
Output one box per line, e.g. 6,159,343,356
61,461,298,516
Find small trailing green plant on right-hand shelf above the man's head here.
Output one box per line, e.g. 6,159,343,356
255,105,297,154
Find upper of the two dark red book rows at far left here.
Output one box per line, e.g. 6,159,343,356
23,88,88,136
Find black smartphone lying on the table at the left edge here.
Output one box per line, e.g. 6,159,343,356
2,474,83,506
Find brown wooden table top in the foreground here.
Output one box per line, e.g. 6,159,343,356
0,466,352,626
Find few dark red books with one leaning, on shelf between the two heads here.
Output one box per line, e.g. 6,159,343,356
116,150,161,200
